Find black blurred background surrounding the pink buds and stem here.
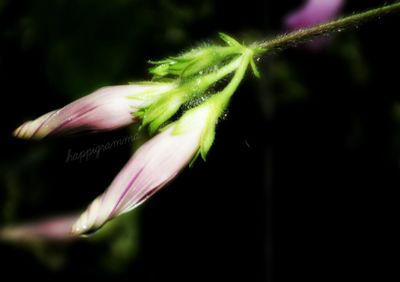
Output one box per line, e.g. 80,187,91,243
0,0,400,281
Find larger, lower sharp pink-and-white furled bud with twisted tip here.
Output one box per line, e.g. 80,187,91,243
72,106,214,235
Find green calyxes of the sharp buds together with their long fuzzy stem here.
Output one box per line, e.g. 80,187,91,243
130,3,400,161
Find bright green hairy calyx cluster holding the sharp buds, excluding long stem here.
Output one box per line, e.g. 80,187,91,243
135,33,264,137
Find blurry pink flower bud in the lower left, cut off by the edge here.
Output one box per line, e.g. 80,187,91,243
0,215,77,241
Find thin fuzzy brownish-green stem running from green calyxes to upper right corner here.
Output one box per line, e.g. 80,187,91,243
255,2,400,52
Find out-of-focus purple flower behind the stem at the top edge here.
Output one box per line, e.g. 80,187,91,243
284,0,344,49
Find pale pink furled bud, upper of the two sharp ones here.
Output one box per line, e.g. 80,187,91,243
13,83,174,139
